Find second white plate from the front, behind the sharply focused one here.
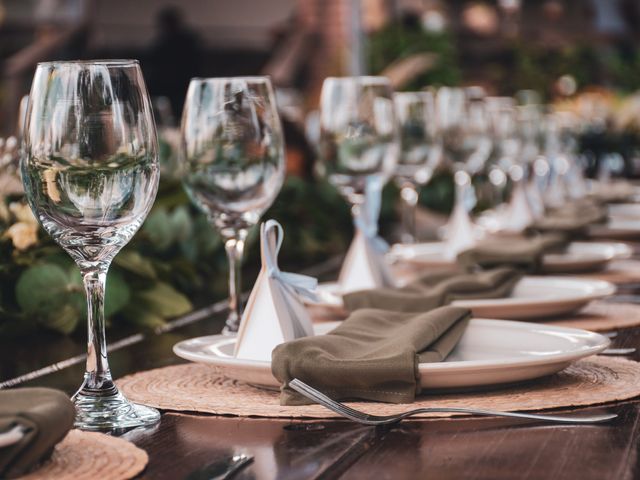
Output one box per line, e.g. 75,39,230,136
318,276,616,320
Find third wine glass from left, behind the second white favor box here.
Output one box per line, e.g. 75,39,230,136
318,76,398,240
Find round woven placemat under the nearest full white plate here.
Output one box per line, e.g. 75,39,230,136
117,357,640,418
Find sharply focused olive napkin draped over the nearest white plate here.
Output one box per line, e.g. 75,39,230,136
271,307,471,405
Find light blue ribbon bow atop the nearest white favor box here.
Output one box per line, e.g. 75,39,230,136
260,220,318,302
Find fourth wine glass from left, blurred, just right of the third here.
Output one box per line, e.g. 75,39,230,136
393,91,441,243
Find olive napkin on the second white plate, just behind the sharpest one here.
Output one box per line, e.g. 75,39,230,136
342,268,522,312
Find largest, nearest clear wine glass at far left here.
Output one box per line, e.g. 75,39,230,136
22,60,160,430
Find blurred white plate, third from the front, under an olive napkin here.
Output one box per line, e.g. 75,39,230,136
388,242,632,273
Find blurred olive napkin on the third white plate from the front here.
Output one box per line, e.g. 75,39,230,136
457,233,567,273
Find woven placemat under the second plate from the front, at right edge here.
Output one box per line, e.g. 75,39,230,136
544,301,640,332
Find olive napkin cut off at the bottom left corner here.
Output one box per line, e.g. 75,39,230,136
0,388,75,478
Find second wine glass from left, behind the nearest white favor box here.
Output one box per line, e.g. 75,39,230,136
181,77,285,334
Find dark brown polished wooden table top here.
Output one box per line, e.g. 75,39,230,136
0,262,640,480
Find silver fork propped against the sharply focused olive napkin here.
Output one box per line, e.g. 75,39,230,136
289,378,617,425
